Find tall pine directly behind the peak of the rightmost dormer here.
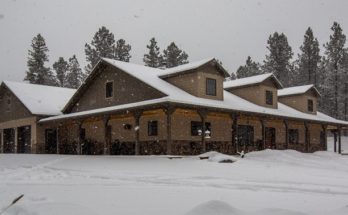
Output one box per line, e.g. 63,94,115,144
298,27,321,86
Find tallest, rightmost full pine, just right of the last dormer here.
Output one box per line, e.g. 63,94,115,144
324,22,346,118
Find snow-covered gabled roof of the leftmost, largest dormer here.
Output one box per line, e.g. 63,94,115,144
159,58,230,78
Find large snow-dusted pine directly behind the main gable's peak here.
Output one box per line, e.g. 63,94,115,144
85,26,115,73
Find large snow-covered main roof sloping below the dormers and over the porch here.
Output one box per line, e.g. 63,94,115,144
40,58,348,125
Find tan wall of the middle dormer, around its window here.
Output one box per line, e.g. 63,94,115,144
228,83,278,108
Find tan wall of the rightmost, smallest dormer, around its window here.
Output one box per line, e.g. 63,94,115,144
279,93,318,114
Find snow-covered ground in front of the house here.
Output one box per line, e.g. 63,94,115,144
0,139,348,215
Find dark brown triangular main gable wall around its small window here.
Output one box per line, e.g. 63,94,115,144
72,66,165,112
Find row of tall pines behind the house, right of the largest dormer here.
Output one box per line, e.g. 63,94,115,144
231,22,348,120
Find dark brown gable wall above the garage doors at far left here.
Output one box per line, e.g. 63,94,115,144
0,86,33,122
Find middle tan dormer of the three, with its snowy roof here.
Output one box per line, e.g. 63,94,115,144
224,73,283,109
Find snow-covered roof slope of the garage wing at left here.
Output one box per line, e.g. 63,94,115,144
3,81,76,116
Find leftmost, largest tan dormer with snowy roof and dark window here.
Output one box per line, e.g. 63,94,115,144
159,59,229,100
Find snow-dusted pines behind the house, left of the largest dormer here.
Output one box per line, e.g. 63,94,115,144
24,26,189,89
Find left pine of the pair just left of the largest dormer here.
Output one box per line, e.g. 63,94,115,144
143,37,163,68
